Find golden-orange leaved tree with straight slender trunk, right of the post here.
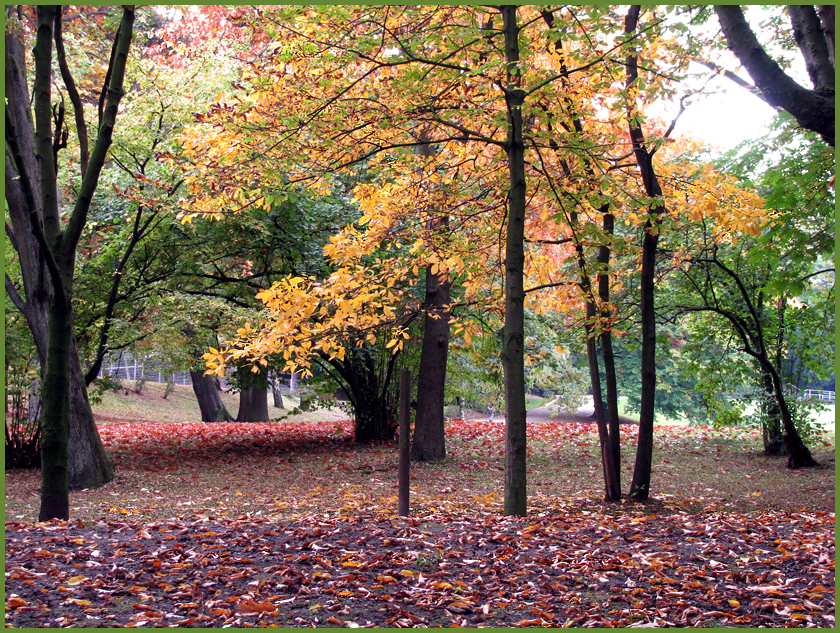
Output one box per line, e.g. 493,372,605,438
186,7,784,514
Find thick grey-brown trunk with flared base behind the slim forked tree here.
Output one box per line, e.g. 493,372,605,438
5,3,114,490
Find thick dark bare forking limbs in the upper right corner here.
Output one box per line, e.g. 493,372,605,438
715,5,834,147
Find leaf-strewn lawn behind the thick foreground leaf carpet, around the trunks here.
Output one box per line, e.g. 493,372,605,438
6,383,834,520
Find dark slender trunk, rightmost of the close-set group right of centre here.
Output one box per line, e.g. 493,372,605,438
624,5,666,501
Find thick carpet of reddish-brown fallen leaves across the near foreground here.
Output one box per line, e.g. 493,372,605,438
6,508,834,627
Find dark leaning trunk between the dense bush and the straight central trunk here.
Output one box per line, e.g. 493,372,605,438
411,266,450,462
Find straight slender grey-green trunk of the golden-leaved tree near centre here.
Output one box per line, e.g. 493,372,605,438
499,6,528,516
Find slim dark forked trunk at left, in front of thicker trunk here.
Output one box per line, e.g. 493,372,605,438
5,6,134,521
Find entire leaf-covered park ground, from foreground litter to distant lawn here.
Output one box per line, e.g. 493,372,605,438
5,380,835,627
